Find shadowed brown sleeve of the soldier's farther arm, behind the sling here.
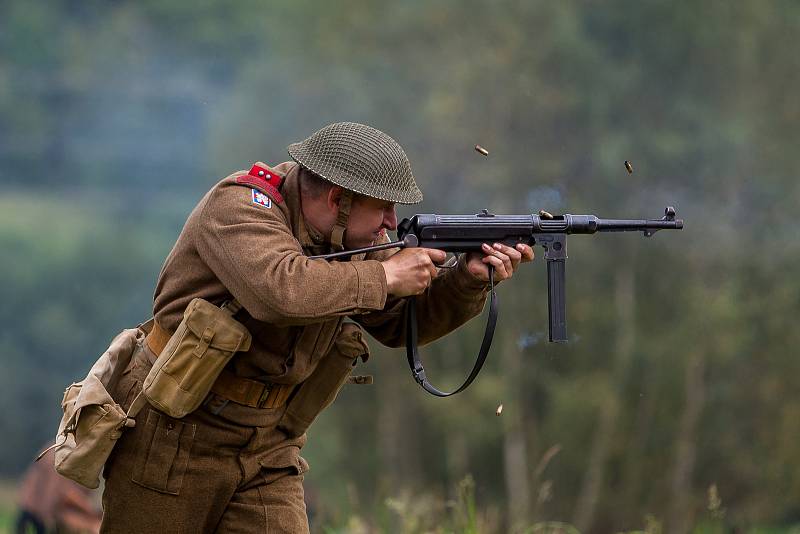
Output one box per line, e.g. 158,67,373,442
353,254,488,347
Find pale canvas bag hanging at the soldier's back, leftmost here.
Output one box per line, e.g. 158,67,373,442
48,328,150,488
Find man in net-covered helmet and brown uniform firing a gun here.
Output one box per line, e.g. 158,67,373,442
103,123,533,532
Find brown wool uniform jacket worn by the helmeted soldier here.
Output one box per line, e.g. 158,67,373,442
154,162,486,392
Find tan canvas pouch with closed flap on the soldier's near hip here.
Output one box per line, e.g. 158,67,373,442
142,298,251,419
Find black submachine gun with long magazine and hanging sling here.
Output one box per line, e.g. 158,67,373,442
311,206,683,397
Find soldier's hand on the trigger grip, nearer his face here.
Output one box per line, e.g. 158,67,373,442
381,248,447,297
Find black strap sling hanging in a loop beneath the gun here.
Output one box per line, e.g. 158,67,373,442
406,265,497,397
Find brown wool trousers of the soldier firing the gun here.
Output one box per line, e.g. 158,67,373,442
101,346,309,533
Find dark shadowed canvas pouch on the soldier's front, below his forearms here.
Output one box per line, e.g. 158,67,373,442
278,323,369,437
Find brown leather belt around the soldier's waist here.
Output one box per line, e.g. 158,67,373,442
144,321,294,408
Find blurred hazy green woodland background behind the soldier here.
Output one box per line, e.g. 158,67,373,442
0,0,800,532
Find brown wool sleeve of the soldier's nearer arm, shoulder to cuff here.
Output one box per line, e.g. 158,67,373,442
195,184,386,326
